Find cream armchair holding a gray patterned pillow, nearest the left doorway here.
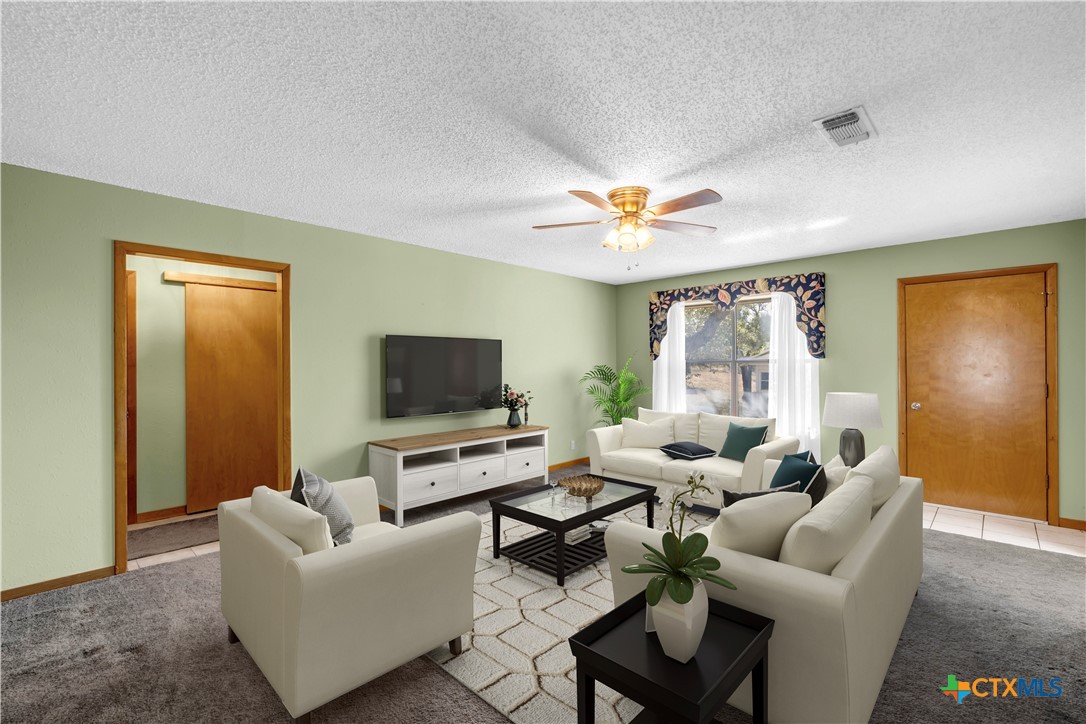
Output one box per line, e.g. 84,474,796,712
218,477,481,722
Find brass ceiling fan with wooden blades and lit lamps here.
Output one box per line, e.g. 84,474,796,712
532,186,721,252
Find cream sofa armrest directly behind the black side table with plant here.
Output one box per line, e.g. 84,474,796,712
604,521,859,722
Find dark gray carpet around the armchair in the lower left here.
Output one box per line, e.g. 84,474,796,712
0,554,506,724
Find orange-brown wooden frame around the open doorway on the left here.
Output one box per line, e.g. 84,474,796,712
113,240,291,573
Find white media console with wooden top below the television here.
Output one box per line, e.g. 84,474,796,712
369,424,547,526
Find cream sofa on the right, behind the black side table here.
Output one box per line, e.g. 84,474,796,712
605,461,923,723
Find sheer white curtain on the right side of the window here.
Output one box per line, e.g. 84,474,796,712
764,292,824,453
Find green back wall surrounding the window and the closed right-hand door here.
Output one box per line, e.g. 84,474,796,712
617,220,1086,520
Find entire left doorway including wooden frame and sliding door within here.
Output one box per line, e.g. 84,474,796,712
113,241,290,573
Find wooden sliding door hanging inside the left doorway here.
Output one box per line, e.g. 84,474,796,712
185,283,279,513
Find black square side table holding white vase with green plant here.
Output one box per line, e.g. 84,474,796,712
569,594,773,724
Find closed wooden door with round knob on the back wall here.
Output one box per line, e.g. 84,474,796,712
902,271,1047,520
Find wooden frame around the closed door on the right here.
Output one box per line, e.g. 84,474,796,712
897,264,1061,525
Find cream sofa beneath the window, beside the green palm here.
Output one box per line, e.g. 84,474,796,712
588,408,799,508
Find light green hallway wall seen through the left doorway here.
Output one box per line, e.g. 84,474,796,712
127,256,276,512
